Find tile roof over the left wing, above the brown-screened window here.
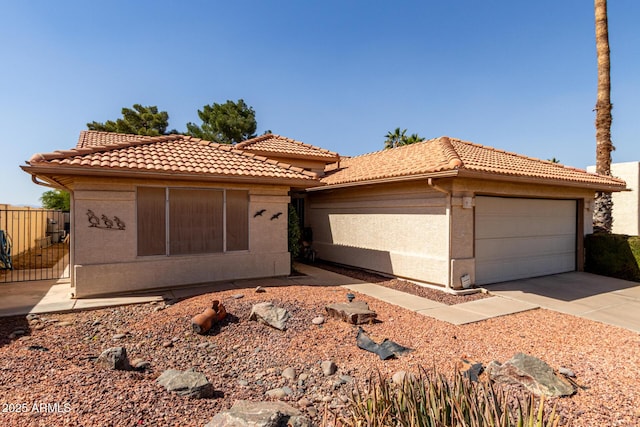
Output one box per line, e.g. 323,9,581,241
28,131,317,182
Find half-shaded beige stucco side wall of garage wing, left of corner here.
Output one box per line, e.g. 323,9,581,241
308,183,449,283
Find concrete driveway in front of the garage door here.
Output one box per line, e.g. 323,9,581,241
485,272,640,332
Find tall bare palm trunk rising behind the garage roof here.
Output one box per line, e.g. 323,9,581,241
593,0,614,233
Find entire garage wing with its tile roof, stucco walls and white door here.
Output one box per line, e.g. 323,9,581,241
306,137,625,289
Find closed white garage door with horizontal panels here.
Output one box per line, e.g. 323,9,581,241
475,197,576,285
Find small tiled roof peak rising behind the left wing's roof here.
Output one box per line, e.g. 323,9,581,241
236,134,340,162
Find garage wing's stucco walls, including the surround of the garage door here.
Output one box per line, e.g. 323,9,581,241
307,178,594,288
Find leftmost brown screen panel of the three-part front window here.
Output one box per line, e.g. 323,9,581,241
137,187,167,256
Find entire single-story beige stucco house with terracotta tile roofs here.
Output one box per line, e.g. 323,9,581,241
22,131,625,297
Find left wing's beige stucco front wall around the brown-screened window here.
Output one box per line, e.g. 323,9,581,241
72,179,290,297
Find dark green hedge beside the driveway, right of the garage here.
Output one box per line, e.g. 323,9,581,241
584,233,640,282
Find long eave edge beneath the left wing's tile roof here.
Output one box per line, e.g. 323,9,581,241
20,165,321,187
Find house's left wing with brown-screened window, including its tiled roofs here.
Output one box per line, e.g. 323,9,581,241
22,131,338,298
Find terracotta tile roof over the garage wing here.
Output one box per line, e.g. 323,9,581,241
321,137,625,189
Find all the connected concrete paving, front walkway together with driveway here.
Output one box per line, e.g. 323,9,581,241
0,264,640,332
